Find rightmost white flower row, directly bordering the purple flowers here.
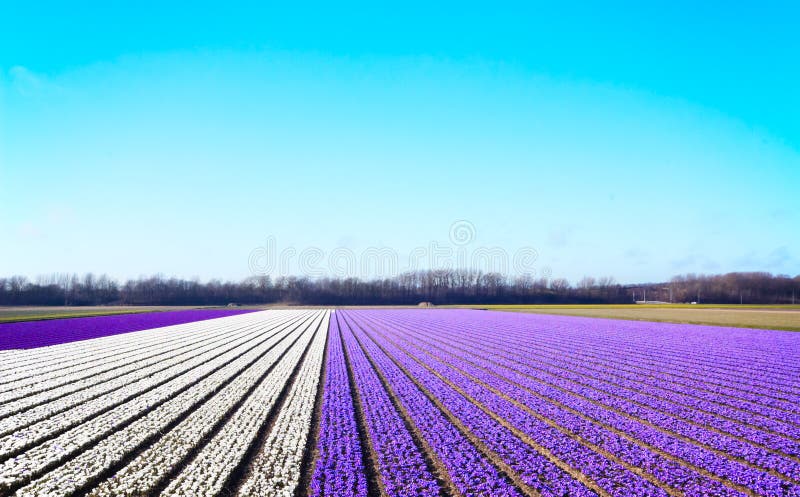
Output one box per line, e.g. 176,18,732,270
236,315,330,497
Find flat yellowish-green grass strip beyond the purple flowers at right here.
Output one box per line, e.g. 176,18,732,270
446,304,800,331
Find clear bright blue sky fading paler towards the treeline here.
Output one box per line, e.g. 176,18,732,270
0,1,800,282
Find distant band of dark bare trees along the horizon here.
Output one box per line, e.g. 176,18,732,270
0,270,800,306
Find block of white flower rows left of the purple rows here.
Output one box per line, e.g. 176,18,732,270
0,311,328,496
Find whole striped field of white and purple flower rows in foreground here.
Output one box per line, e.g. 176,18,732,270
0,309,800,497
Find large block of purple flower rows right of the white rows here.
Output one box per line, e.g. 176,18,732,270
311,310,800,497
